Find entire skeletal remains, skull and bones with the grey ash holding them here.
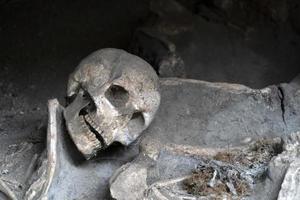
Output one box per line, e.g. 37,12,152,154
0,49,300,200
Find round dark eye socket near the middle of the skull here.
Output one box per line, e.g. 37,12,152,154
105,85,129,107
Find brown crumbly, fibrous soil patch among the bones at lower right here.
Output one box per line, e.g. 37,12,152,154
183,139,282,199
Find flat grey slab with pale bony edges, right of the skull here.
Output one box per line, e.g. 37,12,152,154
145,79,299,147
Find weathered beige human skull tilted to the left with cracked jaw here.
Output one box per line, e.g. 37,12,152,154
64,49,160,159
